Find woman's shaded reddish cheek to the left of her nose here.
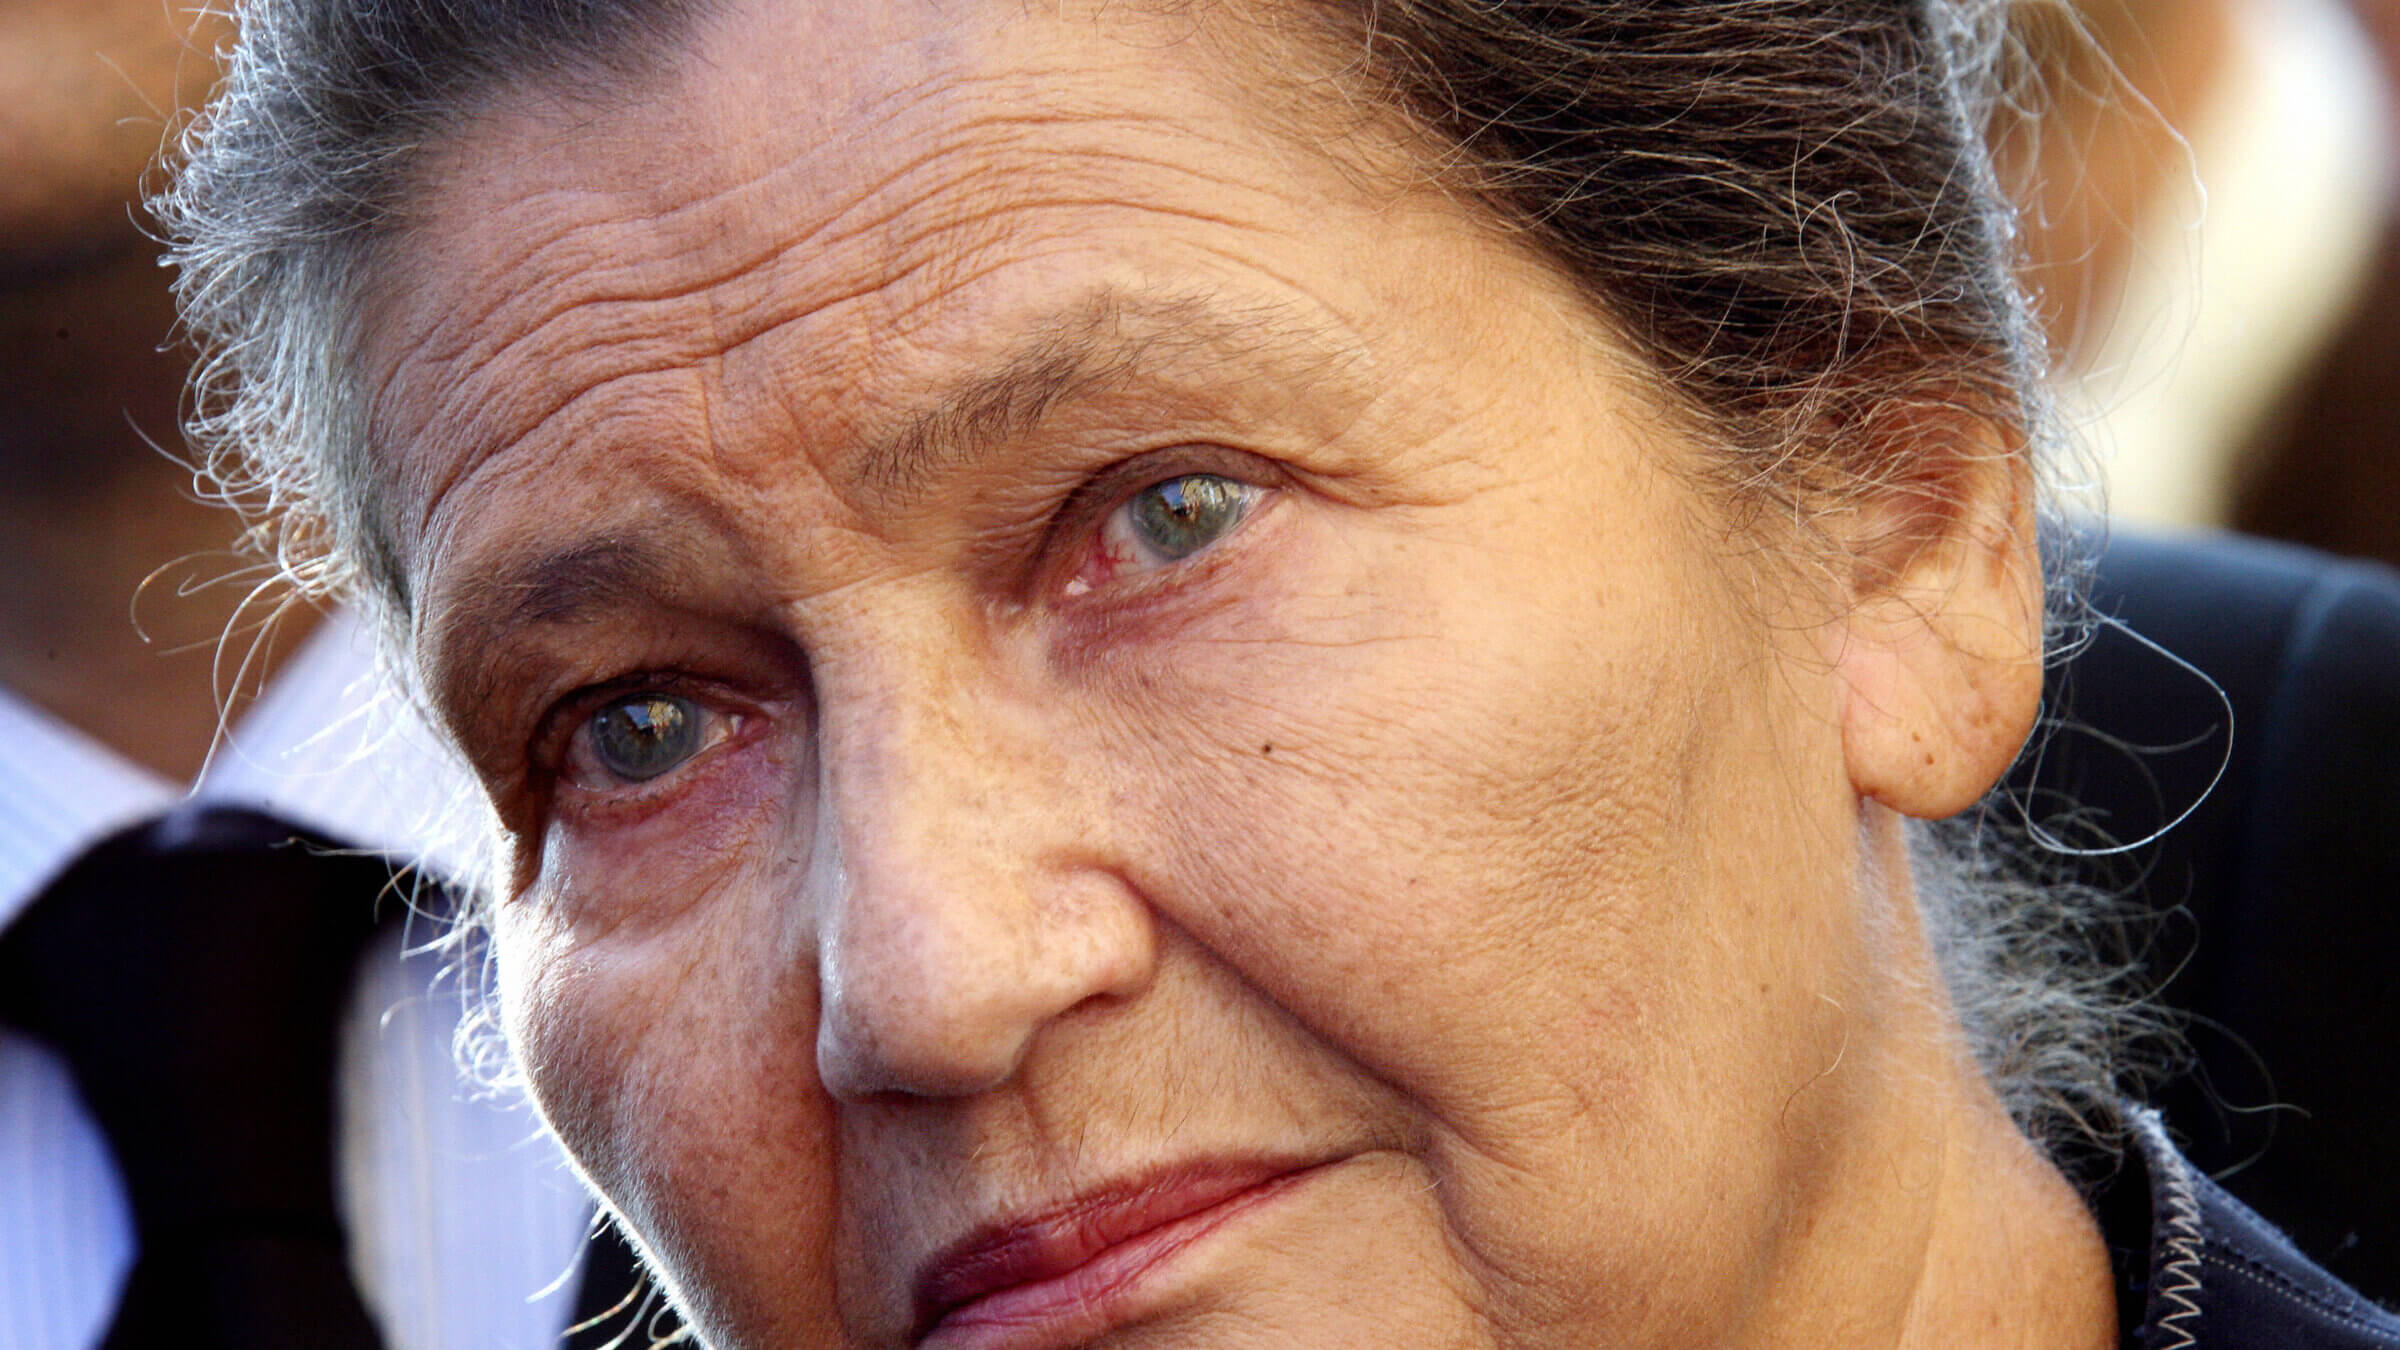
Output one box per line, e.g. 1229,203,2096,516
494,850,838,1345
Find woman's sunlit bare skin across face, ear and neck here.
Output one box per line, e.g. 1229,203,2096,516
367,0,2110,1350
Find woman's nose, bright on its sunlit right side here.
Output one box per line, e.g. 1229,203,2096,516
811,648,1157,1100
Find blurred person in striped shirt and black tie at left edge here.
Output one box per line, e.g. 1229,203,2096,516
0,0,631,1350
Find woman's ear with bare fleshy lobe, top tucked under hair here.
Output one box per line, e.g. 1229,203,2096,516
1826,413,2042,819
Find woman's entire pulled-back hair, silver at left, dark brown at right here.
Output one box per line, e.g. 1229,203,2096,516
154,0,2141,1146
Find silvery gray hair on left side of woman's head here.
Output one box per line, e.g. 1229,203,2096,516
149,0,701,620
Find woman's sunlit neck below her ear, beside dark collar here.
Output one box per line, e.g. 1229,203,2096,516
1752,807,2117,1350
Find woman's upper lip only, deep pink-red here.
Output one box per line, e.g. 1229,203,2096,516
912,1158,1308,1340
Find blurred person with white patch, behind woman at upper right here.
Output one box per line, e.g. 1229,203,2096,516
2004,0,2400,560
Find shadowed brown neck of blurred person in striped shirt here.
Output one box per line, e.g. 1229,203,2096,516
0,235,319,783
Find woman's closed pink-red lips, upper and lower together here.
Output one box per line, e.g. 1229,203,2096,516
914,1160,1313,1345
